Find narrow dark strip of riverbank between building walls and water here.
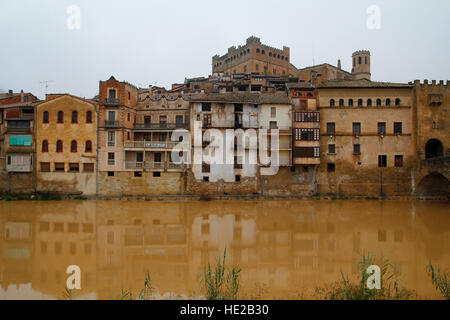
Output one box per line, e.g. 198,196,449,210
0,193,450,201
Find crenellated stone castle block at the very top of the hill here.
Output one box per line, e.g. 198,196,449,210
212,36,296,75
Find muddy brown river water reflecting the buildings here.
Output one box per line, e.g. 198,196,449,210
0,200,450,299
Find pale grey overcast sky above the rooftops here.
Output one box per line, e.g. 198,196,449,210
0,0,450,98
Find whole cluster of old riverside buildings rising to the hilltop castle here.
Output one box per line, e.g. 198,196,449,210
0,37,450,198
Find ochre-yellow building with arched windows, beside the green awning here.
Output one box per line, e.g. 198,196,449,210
35,94,98,195
